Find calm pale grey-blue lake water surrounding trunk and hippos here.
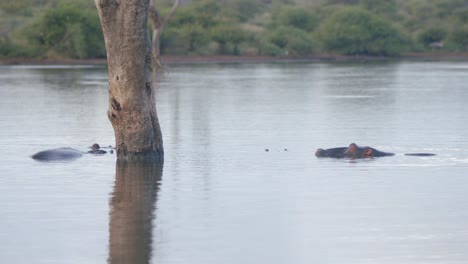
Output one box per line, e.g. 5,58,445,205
0,62,468,264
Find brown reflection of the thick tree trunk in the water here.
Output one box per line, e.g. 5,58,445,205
108,161,163,263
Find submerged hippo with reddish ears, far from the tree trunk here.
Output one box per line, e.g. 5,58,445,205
315,143,435,159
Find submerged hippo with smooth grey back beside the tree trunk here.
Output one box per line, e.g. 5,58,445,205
31,143,113,161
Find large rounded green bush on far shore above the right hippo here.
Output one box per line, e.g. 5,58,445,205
319,7,407,56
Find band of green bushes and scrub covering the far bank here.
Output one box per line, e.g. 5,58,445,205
0,0,468,61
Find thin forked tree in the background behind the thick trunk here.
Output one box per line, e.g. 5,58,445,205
149,0,180,62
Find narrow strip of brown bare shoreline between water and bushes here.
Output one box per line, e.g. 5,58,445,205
0,52,468,65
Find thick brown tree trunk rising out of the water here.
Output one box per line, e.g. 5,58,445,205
95,0,164,161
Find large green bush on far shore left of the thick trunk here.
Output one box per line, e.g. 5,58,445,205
25,2,106,59
